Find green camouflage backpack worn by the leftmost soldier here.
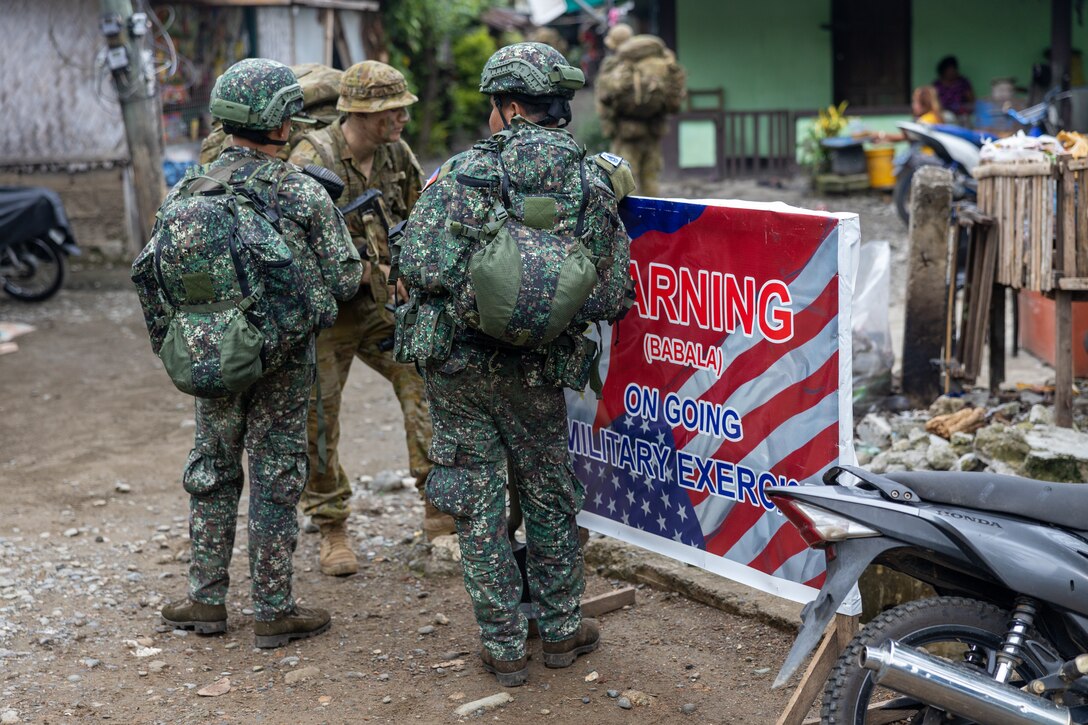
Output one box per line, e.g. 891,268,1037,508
134,159,316,397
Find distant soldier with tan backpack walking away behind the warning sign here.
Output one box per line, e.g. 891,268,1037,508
596,23,688,196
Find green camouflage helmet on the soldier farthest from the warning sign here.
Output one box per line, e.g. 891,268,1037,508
208,58,312,131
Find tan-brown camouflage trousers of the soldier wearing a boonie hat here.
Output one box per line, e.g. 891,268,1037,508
302,290,431,525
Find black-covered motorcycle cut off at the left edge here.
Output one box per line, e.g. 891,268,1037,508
0,186,79,302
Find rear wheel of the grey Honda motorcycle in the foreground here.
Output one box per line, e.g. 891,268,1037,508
820,597,1053,725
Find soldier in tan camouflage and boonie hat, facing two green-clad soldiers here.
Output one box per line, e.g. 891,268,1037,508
290,61,454,576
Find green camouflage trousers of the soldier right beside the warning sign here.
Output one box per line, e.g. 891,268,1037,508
426,348,585,660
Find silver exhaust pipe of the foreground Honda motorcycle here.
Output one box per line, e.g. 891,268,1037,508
857,640,1073,725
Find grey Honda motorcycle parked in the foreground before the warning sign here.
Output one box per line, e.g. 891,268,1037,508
766,466,1088,725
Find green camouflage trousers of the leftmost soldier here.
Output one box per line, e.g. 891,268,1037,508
182,348,313,622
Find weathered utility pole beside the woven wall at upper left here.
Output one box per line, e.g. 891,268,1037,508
99,0,166,251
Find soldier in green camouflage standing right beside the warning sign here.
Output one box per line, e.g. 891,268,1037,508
395,42,633,687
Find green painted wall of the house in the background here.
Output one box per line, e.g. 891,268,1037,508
677,0,1088,167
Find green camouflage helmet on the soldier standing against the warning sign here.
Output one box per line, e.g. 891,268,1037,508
480,42,585,98
